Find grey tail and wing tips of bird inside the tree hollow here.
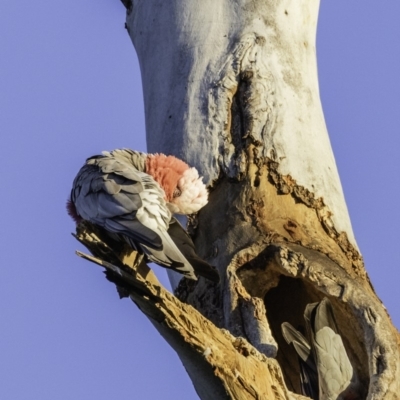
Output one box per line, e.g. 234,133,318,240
281,297,353,400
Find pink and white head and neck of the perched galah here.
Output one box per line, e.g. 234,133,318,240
146,154,208,215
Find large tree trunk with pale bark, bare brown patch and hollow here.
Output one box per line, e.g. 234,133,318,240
99,0,400,400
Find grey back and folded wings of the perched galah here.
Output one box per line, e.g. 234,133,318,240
71,149,203,279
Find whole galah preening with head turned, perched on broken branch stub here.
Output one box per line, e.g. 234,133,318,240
67,149,219,282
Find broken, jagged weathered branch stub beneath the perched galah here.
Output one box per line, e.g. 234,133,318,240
76,223,303,400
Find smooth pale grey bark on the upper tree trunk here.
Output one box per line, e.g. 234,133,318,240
127,0,355,245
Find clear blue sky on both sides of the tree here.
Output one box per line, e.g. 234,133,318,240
0,0,400,400
